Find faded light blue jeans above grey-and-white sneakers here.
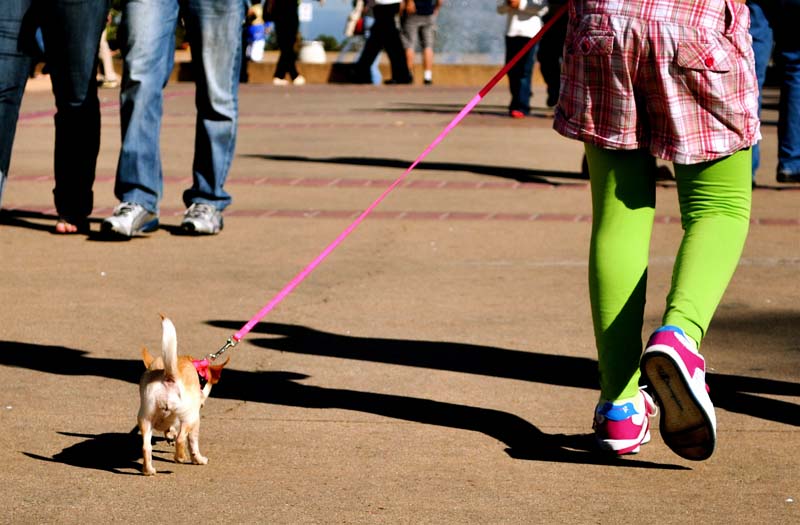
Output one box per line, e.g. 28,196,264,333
114,0,245,213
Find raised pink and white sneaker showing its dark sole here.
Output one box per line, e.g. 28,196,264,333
641,326,717,461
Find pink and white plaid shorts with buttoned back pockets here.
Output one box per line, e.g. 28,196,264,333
553,0,760,164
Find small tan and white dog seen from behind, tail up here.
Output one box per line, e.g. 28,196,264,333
138,315,230,476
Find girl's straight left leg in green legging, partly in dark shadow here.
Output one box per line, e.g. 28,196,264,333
586,144,655,400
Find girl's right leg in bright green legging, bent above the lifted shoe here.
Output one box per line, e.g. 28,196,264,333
663,149,752,346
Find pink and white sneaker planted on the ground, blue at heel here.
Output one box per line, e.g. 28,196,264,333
592,384,656,456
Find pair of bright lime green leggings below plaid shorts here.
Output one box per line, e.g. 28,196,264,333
586,144,752,400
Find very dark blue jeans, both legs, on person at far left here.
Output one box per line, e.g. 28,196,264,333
0,0,108,220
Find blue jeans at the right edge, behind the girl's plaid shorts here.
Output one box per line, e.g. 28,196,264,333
747,0,800,177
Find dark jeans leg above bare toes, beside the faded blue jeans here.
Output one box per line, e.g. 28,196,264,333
42,0,108,220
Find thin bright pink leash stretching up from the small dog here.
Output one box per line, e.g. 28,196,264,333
206,4,568,361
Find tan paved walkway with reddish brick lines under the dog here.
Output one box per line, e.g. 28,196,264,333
0,80,800,524
